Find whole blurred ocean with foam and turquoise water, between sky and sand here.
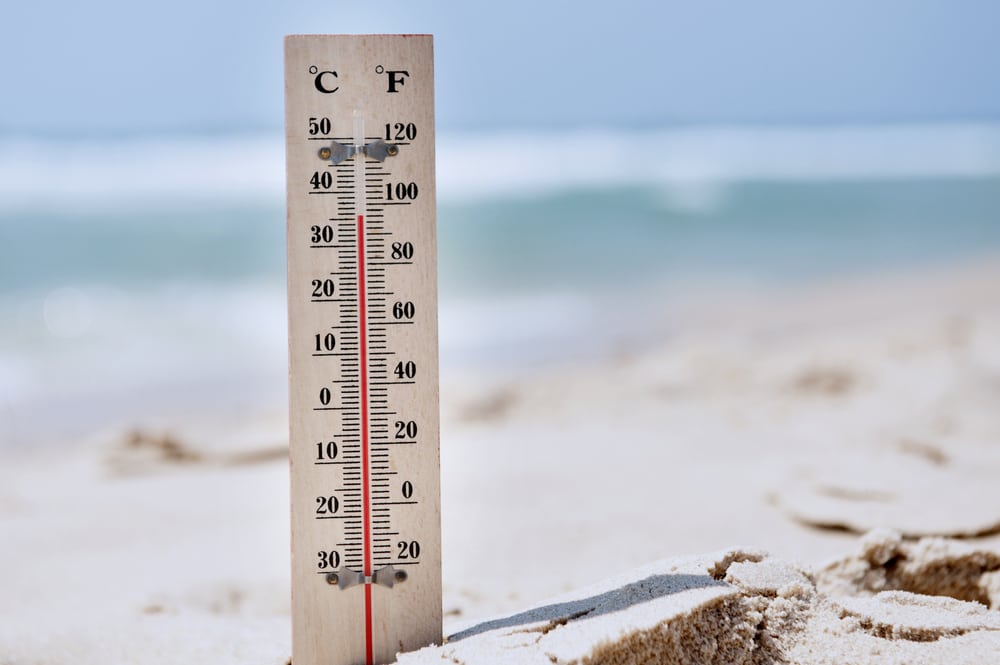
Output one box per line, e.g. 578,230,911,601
0,124,1000,448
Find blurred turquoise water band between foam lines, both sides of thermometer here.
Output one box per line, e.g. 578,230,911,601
0,177,1000,298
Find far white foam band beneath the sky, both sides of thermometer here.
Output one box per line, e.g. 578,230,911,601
0,124,1000,208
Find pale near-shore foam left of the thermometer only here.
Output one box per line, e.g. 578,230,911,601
0,284,287,449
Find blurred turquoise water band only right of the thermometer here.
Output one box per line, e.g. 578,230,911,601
440,177,1000,292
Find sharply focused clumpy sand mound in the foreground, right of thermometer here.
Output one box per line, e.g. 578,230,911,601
398,534,1000,665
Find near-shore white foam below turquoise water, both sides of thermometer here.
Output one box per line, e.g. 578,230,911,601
0,283,599,451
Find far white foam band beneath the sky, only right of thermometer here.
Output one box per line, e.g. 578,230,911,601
438,125,1000,197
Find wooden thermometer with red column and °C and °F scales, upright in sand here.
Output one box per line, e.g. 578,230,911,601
285,35,441,665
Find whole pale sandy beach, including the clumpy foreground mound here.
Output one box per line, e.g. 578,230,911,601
0,261,1000,665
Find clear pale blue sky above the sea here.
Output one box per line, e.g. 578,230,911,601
0,0,1000,137
